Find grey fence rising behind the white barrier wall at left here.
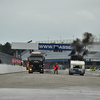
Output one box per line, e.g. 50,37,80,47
0,52,20,64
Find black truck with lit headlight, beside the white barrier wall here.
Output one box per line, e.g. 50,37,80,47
27,52,45,73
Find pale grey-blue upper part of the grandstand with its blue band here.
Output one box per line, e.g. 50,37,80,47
22,42,100,61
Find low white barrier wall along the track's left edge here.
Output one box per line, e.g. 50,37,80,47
0,64,26,74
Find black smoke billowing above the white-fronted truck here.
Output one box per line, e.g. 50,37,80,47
71,32,94,56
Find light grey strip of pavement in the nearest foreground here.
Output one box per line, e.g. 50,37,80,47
0,86,100,100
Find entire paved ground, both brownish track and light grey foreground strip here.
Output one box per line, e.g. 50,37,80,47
0,70,100,100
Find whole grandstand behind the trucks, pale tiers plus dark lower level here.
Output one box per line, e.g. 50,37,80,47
22,42,100,69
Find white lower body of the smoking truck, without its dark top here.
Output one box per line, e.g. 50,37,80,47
69,60,85,75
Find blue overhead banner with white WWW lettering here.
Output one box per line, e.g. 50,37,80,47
38,43,71,51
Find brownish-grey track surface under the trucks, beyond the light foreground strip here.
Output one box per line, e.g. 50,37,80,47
0,70,100,89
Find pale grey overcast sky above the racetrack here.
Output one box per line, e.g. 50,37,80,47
0,0,100,44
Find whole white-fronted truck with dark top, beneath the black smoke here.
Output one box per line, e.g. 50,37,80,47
69,55,85,76
